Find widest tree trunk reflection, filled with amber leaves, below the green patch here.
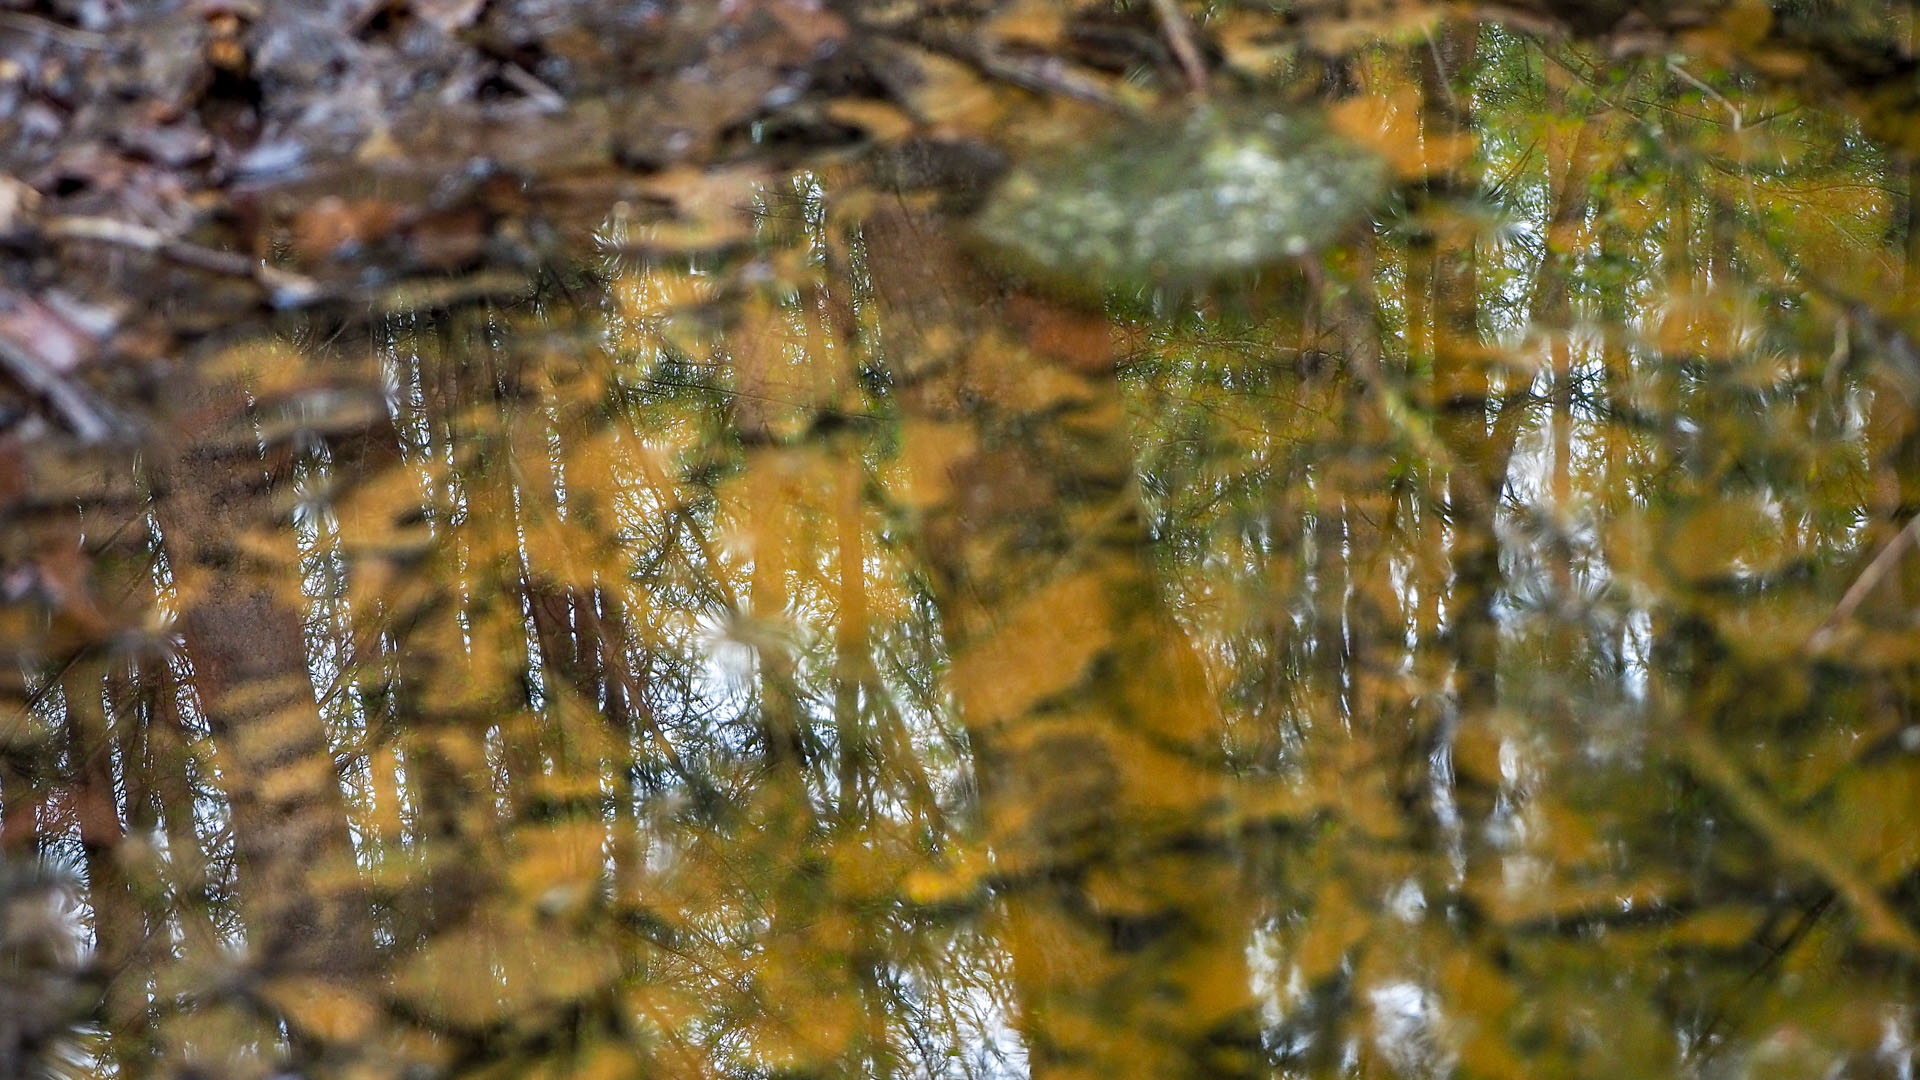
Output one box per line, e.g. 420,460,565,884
866,203,1263,1078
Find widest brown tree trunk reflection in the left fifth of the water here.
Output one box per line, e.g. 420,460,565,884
157,368,372,976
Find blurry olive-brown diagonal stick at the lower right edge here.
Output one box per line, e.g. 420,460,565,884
1680,723,1920,959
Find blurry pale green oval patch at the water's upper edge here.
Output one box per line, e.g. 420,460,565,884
973,110,1386,288
